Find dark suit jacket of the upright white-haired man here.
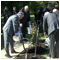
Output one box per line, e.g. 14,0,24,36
20,9,30,27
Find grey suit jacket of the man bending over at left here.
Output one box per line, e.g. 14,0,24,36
3,15,19,36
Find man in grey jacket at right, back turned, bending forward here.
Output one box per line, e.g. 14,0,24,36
43,12,59,58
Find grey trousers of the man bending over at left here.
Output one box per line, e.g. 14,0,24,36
3,31,14,55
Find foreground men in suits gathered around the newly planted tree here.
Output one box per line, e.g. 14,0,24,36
3,6,59,58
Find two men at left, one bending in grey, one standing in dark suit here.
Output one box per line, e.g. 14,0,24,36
3,6,30,57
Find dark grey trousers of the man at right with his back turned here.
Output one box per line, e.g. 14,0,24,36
49,30,59,58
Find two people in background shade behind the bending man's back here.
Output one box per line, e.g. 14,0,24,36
1,6,17,24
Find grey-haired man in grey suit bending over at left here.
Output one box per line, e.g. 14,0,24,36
3,12,24,58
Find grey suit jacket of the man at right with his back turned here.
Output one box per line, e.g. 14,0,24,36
43,13,59,35
